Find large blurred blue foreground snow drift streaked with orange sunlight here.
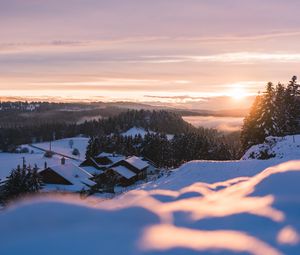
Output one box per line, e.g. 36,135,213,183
0,161,300,255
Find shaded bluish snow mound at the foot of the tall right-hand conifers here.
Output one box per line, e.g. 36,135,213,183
242,135,300,160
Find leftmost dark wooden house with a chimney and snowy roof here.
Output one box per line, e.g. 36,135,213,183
39,158,96,191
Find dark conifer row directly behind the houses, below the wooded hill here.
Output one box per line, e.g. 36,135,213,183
86,128,240,168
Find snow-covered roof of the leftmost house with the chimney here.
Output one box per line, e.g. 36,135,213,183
42,163,96,187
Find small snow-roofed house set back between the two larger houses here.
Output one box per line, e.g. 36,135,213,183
80,152,125,175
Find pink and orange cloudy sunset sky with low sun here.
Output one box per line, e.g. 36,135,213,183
0,0,300,109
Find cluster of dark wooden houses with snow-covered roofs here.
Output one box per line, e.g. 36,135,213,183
39,152,157,191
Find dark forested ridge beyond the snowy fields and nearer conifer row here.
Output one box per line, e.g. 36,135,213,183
0,110,194,152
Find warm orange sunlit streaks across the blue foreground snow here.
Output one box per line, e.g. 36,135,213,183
2,161,300,255
